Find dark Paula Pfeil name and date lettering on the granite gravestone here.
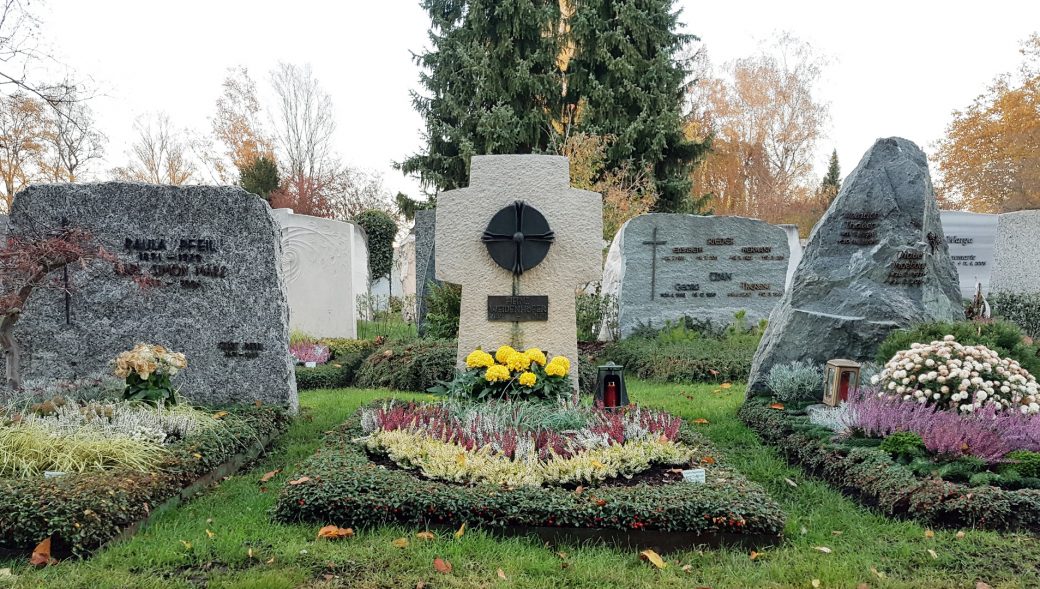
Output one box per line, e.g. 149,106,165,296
116,237,228,289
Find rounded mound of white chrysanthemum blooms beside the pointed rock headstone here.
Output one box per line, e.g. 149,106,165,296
870,335,1040,414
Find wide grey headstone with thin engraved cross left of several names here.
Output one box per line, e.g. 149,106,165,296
603,213,790,337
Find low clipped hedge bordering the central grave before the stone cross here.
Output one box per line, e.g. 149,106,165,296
275,403,784,547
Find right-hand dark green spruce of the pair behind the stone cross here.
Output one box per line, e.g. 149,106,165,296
567,0,707,212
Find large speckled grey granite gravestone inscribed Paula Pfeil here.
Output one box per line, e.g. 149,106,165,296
10,182,297,410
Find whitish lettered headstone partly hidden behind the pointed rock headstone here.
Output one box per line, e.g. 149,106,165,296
939,210,998,299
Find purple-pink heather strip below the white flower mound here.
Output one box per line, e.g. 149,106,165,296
847,390,1040,463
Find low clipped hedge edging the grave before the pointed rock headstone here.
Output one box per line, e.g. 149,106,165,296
739,396,1040,533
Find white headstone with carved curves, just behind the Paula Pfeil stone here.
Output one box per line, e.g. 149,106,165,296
274,209,368,338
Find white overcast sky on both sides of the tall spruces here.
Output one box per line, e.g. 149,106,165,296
34,0,1040,202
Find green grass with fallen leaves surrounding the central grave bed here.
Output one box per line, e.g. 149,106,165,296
0,382,1040,589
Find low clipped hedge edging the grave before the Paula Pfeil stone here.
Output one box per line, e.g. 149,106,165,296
0,407,289,558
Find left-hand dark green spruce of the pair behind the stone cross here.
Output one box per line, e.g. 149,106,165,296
399,0,561,191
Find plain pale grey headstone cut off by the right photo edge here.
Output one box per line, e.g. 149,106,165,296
990,210,1040,295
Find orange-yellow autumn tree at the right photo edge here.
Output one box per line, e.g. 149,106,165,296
935,33,1040,213
